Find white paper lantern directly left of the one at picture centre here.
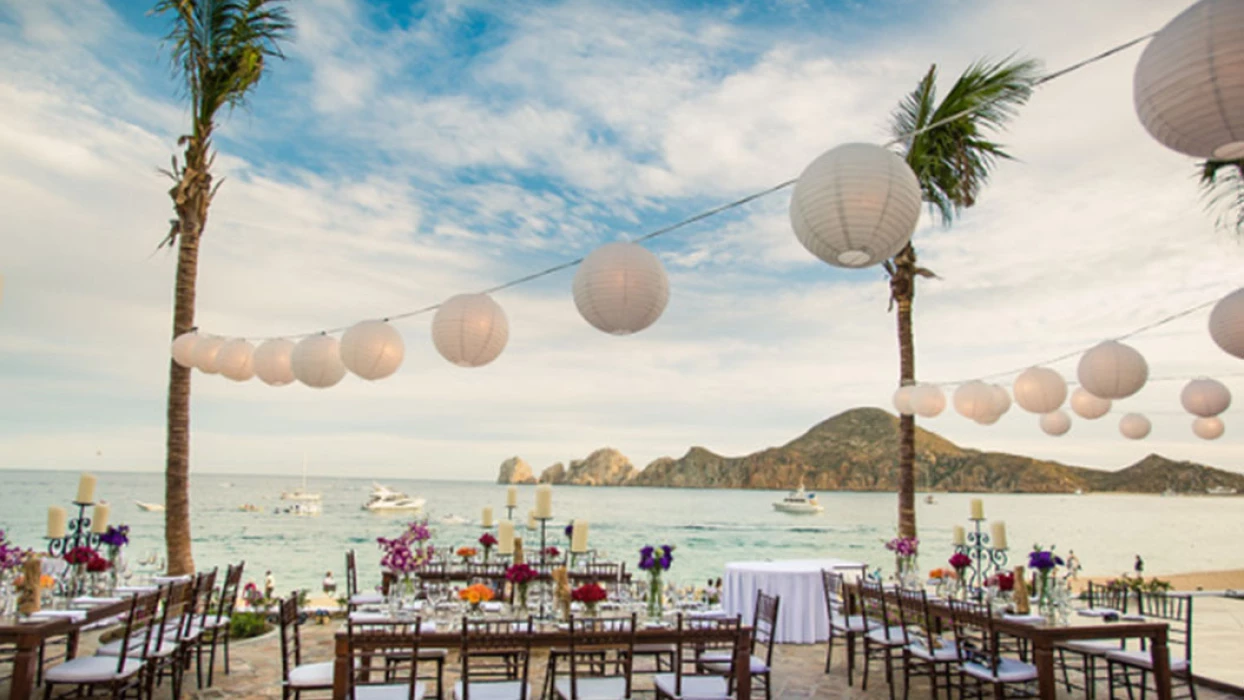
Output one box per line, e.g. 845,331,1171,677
432,293,505,367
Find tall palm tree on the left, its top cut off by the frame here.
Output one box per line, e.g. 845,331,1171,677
154,0,294,574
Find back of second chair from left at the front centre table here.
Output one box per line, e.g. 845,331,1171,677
458,617,532,700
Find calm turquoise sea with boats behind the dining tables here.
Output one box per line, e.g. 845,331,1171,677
0,471,1244,591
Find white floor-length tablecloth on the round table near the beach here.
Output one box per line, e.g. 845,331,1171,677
722,560,863,644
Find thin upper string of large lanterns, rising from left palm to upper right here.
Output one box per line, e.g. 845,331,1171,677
223,32,1156,343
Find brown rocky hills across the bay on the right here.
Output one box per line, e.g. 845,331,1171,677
503,408,1244,494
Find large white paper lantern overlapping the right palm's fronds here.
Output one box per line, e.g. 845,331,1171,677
790,143,921,267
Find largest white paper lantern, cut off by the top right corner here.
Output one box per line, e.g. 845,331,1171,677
1132,0,1244,160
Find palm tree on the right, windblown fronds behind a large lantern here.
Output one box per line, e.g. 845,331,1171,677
884,58,1037,537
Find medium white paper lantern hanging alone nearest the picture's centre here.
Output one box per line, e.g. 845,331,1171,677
572,242,669,335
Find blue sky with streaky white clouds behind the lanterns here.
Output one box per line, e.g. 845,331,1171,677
0,0,1244,479
